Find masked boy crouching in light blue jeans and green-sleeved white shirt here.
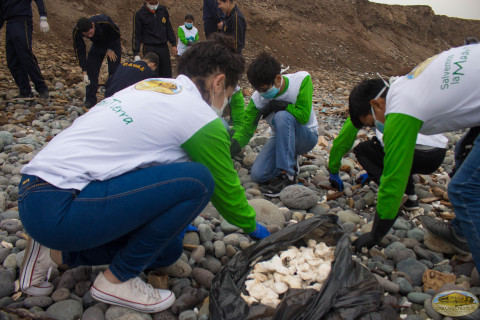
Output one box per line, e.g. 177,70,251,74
231,53,318,197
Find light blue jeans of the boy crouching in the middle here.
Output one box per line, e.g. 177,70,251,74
251,111,318,183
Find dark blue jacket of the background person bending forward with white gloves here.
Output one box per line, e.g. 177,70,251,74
73,14,120,71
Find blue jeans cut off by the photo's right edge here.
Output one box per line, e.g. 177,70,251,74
448,136,480,269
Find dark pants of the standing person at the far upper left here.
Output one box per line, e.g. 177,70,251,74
6,20,48,95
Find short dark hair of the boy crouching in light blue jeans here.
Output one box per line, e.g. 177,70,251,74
247,52,282,90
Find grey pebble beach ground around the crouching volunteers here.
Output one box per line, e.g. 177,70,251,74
0,39,480,320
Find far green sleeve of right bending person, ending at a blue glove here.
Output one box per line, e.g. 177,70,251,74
328,117,358,174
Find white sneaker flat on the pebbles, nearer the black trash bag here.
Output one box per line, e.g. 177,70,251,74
90,272,175,313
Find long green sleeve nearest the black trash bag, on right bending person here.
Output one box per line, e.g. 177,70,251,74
377,113,423,220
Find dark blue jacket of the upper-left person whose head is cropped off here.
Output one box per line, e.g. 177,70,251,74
0,0,47,28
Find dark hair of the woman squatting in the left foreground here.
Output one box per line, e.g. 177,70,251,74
177,33,245,101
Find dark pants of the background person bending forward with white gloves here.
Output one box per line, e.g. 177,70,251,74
86,40,122,105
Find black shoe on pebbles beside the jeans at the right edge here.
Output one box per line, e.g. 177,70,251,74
419,216,470,254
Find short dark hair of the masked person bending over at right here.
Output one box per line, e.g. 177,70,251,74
348,79,388,129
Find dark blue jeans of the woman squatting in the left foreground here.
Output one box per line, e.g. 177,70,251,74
19,162,214,281
